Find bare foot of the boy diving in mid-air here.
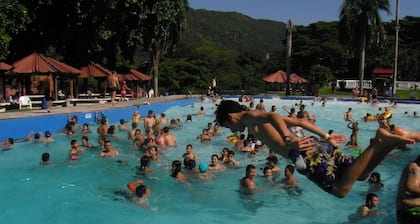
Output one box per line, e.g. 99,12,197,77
373,128,416,148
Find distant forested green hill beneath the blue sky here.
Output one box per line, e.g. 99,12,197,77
181,9,286,57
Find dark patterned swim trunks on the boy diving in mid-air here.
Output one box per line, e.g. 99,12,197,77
289,137,354,192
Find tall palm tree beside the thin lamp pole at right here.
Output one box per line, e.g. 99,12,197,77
339,0,391,94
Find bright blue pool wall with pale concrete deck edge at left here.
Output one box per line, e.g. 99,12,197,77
0,95,199,141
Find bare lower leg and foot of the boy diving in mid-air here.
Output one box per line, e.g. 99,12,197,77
331,128,414,198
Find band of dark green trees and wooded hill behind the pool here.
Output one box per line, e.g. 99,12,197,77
0,0,420,94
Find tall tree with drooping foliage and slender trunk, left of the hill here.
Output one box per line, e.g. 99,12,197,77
140,0,188,95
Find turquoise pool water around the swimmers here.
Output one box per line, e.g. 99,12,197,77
0,99,420,223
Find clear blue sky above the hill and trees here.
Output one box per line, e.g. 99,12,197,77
188,0,420,26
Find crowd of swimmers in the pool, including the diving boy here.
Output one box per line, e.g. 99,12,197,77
3,96,420,222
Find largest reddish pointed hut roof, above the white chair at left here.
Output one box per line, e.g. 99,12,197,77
9,53,80,75
